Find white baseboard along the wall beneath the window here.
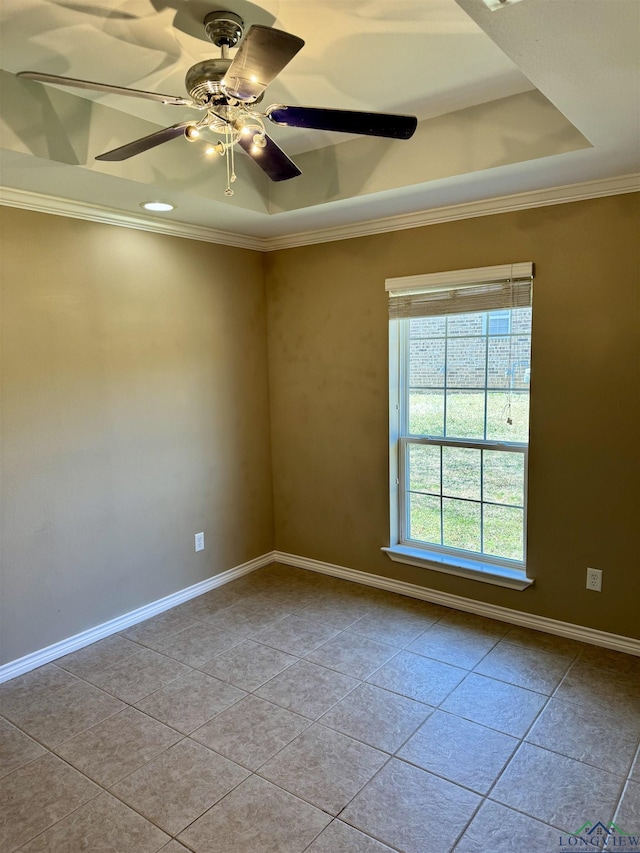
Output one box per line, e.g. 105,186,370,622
273,551,640,656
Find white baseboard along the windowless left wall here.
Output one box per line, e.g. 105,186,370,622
0,552,274,684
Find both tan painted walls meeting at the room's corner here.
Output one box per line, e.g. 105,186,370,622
0,195,640,664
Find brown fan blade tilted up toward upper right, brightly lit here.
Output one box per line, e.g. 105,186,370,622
222,25,304,102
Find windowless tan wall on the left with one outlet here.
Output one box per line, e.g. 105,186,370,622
0,208,273,663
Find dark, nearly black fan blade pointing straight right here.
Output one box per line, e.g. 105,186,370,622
265,104,418,139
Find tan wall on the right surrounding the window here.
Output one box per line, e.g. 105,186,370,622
265,195,640,637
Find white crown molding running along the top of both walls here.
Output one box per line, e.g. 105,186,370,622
0,173,640,252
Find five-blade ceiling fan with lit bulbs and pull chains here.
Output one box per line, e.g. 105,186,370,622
17,11,417,196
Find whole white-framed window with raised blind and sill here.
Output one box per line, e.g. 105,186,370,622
384,263,533,588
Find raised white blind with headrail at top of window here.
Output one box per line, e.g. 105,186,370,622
385,262,533,319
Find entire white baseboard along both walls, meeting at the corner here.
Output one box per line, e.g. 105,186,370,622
0,551,640,684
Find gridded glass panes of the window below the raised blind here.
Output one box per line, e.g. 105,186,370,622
397,307,531,566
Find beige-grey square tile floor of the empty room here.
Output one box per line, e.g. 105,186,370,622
0,565,640,853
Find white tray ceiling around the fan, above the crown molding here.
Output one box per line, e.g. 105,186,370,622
0,0,640,238
